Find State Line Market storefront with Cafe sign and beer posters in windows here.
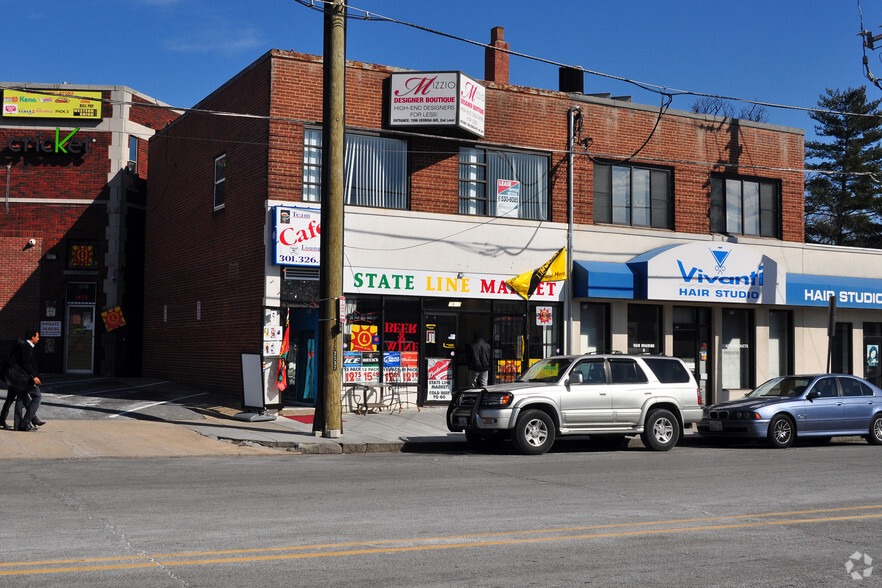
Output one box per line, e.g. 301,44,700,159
264,206,565,406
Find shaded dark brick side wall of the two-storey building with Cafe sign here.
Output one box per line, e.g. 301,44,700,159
143,52,270,392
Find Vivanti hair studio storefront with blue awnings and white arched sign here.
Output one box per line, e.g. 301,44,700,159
573,241,882,402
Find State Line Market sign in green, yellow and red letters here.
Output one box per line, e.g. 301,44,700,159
343,267,566,302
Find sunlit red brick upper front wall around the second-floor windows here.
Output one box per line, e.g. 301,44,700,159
270,51,804,242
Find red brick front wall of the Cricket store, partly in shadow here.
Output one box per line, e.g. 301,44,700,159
0,127,110,372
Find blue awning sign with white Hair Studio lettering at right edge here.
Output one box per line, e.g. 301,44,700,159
787,274,882,309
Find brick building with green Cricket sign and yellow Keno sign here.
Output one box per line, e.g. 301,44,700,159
0,84,175,375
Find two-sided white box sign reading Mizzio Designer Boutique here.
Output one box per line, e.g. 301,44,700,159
388,71,487,137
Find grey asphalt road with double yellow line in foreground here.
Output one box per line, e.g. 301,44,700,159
0,441,882,586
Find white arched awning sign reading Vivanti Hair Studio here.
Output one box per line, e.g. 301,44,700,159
628,243,785,304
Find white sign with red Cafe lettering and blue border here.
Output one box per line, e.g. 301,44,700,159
275,206,321,267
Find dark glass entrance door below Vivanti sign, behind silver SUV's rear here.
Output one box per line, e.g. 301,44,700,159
674,306,714,405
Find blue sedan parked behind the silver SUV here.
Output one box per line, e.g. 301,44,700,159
698,374,882,448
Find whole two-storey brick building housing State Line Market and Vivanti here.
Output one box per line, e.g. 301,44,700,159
144,28,882,406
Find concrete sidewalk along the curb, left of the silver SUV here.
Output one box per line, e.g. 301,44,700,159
0,378,466,460
